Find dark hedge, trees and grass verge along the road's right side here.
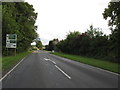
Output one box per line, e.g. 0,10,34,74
46,1,120,73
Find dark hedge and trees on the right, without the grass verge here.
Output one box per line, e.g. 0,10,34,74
47,1,120,62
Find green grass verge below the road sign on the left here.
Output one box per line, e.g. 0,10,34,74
2,51,31,72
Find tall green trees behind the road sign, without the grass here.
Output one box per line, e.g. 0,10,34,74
2,2,38,55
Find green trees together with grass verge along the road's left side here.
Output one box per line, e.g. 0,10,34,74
2,2,42,74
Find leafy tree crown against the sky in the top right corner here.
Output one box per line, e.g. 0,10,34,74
103,1,120,29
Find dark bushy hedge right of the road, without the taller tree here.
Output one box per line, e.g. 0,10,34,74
57,25,117,62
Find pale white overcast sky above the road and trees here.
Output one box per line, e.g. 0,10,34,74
25,0,111,45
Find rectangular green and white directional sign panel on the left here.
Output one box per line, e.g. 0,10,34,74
6,34,17,48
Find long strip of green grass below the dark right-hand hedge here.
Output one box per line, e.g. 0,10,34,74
51,52,120,73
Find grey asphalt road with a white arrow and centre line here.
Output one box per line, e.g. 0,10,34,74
2,51,118,88
